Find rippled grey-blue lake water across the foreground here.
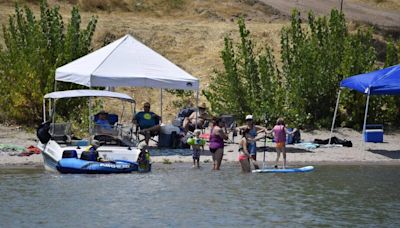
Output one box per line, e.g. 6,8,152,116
0,163,400,227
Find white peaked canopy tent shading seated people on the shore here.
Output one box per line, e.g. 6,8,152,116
55,35,199,121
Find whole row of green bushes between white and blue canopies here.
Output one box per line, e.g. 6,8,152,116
203,10,399,128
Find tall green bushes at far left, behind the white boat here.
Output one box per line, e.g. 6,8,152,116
0,1,97,125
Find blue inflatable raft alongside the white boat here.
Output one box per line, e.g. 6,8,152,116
56,158,139,174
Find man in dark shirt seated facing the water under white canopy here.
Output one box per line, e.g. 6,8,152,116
133,102,161,145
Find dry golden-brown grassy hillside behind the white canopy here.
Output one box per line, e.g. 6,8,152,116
0,0,398,123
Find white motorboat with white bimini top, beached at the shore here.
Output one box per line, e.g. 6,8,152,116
38,90,140,171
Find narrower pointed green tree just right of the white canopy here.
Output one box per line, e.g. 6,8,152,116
203,18,281,124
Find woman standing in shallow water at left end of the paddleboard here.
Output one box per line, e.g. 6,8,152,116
238,128,259,173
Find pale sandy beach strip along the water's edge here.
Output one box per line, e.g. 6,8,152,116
0,125,400,168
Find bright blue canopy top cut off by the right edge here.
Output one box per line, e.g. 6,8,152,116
340,64,400,95
